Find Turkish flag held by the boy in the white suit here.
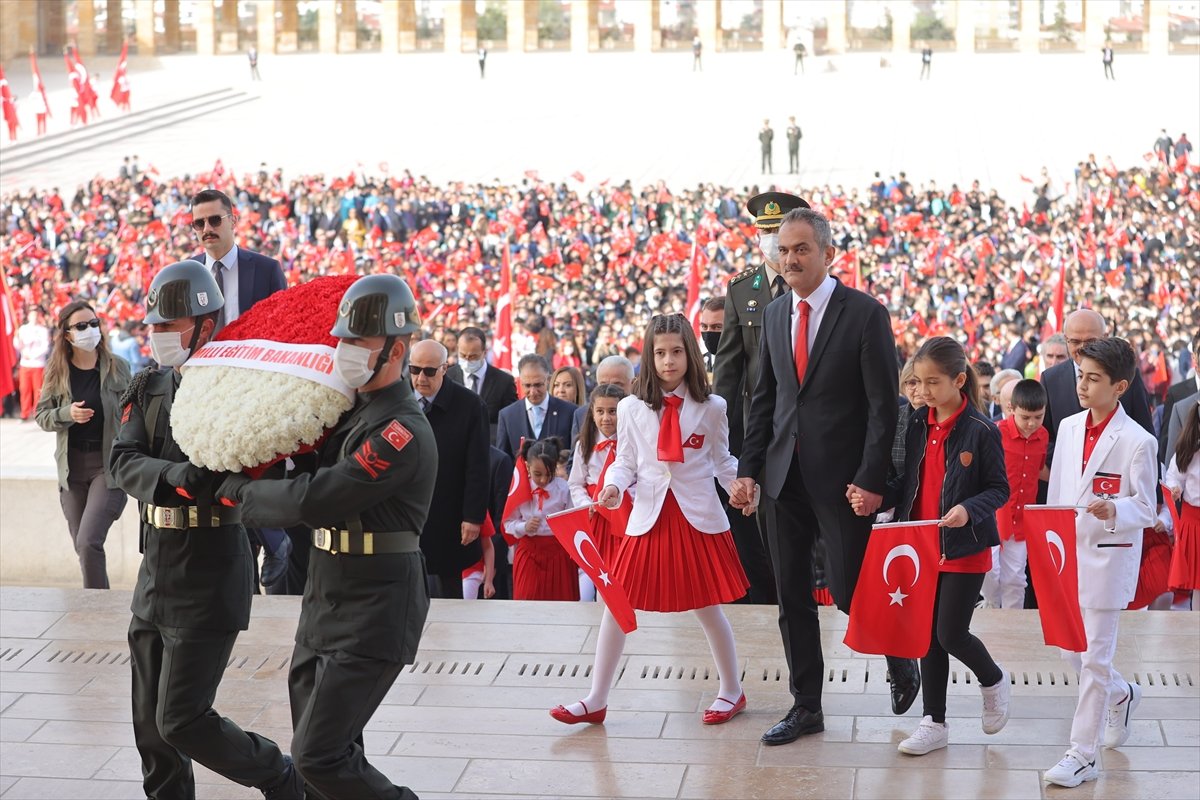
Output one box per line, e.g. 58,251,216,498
1025,505,1087,652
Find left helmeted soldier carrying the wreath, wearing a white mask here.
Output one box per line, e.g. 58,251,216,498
109,261,304,800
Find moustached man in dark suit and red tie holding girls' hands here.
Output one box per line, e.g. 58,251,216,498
731,209,920,745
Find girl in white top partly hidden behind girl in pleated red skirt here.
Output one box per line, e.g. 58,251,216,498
566,384,634,601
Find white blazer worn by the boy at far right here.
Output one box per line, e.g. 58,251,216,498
1046,405,1158,609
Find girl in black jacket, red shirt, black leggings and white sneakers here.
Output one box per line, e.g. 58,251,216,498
854,336,1012,756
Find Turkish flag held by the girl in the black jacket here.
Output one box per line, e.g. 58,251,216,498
845,521,938,658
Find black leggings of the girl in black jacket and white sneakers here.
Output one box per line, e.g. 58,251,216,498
920,572,1004,722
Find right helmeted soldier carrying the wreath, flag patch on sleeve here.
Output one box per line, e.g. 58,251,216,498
218,275,438,800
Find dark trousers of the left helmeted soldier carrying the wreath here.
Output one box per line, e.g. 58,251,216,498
128,616,284,800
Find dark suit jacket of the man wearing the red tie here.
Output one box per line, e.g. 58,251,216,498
738,282,899,503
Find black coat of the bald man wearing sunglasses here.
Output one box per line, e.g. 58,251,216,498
421,380,491,573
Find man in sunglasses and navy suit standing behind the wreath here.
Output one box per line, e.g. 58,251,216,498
192,188,291,594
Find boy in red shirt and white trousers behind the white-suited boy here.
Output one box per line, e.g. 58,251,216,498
992,380,1050,608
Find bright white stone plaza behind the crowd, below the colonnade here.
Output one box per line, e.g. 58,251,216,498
0,53,1200,205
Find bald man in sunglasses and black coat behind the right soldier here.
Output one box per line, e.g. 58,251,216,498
408,339,490,600
